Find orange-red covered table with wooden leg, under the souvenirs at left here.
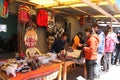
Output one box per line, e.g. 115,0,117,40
0,63,62,80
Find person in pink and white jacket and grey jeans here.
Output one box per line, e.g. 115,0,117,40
103,27,115,72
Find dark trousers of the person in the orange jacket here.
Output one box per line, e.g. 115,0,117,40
85,59,96,80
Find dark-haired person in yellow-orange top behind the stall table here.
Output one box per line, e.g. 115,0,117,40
72,32,84,50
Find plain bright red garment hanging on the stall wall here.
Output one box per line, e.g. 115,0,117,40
37,9,48,27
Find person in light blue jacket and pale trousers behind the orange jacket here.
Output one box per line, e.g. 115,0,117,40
92,23,105,78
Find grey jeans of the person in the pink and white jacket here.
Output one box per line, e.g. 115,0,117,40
103,52,111,71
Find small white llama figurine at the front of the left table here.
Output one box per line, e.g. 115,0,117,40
6,63,18,77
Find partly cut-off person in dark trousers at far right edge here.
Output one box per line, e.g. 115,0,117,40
114,31,120,65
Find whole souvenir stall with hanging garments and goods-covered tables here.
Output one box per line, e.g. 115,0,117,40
0,0,107,80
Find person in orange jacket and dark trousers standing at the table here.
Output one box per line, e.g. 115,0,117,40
83,27,100,80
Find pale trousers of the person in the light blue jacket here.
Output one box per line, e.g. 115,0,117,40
95,53,103,78
